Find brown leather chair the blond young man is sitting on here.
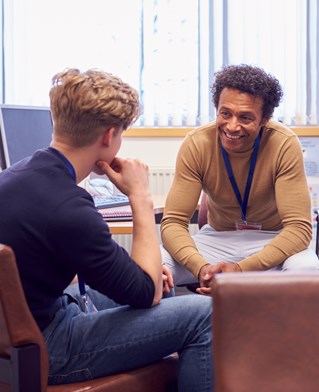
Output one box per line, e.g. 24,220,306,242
0,244,178,392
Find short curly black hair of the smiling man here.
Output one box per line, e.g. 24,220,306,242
211,64,283,120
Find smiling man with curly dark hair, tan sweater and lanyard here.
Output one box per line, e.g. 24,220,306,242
161,64,318,294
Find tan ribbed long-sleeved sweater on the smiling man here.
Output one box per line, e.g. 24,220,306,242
161,121,312,277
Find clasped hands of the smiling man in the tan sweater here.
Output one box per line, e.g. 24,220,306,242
196,261,242,295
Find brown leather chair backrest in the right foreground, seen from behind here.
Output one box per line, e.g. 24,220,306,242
213,271,319,392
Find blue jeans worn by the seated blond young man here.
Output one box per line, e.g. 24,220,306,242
43,285,213,392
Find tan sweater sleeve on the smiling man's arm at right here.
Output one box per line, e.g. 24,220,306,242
239,136,312,271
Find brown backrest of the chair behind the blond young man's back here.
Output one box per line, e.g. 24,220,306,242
0,244,48,392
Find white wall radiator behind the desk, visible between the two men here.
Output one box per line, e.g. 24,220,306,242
112,167,197,252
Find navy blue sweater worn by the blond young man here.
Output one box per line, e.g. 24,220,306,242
0,148,155,330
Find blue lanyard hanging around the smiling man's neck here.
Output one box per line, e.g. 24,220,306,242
221,129,262,222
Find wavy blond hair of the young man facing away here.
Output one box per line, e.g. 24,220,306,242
50,68,140,147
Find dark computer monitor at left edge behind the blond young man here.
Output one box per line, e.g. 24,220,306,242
0,104,53,170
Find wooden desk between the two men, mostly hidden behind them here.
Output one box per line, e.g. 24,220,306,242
107,195,166,234
